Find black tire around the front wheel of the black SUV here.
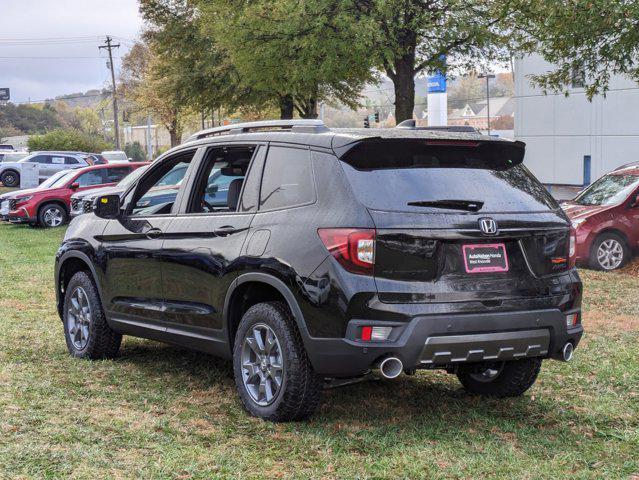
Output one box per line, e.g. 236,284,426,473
63,272,122,360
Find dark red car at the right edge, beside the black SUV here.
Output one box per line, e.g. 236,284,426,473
562,164,639,270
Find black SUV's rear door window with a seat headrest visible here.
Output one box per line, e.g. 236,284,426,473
187,146,255,213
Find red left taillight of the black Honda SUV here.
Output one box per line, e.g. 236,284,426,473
317,228,375,275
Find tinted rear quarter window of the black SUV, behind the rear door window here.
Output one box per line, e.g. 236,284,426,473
260,147,315,210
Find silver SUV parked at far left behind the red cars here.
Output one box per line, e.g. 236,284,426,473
0,152,91,187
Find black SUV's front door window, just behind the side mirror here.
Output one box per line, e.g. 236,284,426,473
129,150,195,216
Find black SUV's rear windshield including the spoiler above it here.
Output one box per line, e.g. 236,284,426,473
342,141,559,213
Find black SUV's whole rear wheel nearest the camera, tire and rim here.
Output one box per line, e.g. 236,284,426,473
233,302,322,422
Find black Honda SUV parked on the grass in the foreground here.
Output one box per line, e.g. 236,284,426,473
56,121,583,421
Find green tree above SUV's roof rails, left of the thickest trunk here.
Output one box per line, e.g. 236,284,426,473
198,0,372,118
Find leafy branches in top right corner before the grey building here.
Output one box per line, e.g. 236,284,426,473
516,0,639,99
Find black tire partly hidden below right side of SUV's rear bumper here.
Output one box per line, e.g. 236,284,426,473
457,358,541,398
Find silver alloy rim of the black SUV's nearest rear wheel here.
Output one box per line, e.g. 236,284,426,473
241,323,284,406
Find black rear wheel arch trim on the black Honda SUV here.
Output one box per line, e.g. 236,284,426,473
224,272,309,350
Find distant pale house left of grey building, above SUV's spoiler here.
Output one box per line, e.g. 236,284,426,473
448,97,515,130
